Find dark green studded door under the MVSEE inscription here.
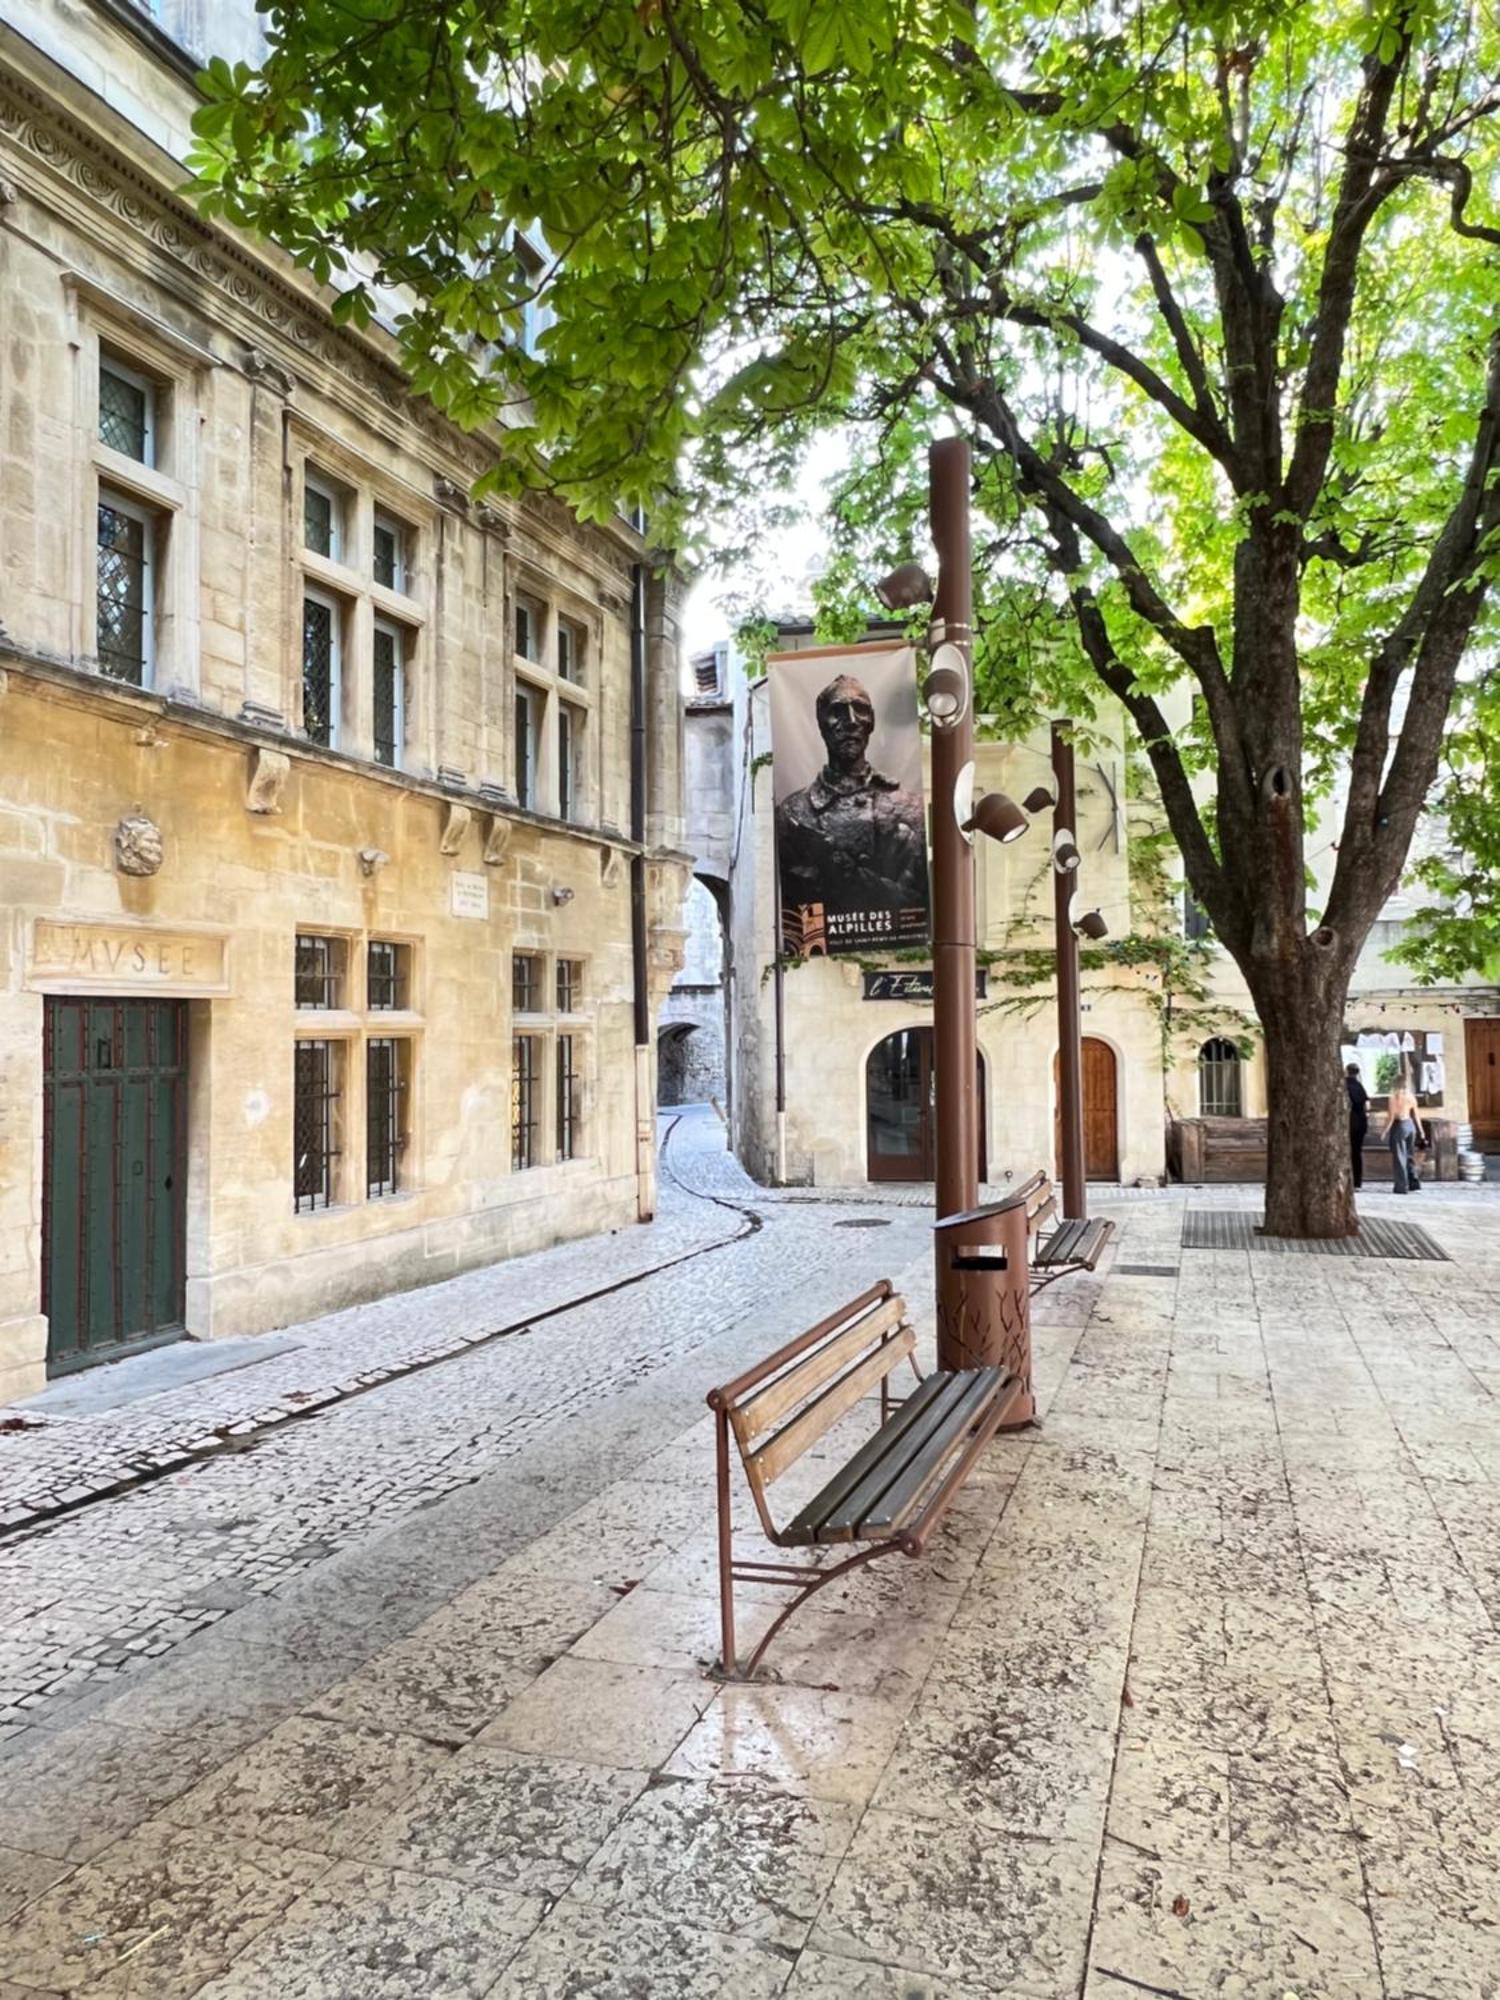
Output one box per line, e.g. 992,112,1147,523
42,1000,188,1374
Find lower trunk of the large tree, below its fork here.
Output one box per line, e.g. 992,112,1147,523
1254,966,1360,1238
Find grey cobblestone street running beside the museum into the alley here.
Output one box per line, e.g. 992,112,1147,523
0,1110,928,1732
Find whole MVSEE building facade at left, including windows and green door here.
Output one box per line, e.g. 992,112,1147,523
0,0,688,1396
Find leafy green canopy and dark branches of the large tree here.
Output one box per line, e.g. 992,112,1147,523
196,0,1500,1224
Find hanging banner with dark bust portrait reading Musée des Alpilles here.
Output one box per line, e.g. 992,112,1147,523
766,640,928,958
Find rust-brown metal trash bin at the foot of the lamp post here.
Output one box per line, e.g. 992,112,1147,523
934,1192,1036,1430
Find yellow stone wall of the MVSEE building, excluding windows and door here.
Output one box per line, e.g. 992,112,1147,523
0,19,686,1398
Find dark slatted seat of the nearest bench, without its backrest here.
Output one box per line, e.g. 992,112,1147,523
784,1368,1006,1542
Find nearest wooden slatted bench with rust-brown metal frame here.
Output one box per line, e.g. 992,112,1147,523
708,1278,1018,1680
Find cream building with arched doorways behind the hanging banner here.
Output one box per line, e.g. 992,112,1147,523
686,620,1166,1186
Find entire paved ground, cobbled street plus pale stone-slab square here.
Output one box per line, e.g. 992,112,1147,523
0,1112,1500,2000
